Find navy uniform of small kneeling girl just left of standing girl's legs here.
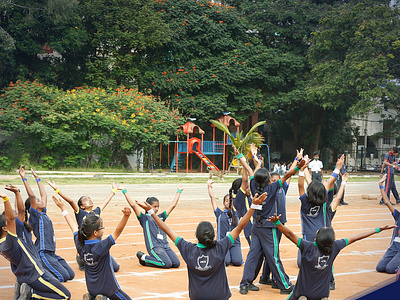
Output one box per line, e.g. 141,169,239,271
214,207,243,266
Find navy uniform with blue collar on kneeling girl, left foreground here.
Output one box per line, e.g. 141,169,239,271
74,232,131,300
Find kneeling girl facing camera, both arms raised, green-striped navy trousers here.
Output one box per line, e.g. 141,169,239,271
122,187,183,269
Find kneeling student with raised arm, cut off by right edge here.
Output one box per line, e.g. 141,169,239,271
376,175,400,274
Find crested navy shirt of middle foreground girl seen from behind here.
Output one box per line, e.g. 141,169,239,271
175,234,234,300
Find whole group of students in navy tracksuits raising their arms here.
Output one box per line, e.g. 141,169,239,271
0,145,400,300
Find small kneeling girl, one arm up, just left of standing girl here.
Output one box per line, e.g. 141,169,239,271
207,179,243,266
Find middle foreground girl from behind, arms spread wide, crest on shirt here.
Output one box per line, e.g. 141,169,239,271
136,193,267,300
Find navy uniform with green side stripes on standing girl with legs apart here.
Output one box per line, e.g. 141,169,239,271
240,177,292,290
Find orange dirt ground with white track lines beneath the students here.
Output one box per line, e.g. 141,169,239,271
0,179,400,300
